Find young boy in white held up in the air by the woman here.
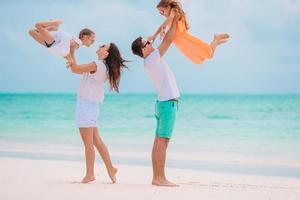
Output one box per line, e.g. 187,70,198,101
29,20,95,59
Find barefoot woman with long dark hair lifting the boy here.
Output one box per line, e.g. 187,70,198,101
68,43,127,183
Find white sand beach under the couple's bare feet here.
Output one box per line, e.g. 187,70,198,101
0,158,300,200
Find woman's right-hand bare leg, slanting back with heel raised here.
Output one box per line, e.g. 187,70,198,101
93,128,118,183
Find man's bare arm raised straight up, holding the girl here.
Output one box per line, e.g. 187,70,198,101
158,12,179,57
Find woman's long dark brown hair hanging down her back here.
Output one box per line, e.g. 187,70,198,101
104,43,127,93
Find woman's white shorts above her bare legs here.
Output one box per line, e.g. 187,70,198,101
75,100,99,128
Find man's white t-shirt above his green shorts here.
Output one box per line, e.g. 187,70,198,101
144,49,180,101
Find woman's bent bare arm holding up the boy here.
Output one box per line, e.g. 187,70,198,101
67,46,97,74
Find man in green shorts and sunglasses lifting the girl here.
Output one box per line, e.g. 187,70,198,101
131,11,180,186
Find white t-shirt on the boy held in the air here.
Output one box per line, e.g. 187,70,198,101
48,31,82,57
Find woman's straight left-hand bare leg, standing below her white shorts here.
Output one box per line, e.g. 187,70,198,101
79,128,95,183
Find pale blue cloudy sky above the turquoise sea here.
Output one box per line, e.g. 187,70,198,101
0,0,300,93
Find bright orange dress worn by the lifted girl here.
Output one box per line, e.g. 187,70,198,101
169,20,213,64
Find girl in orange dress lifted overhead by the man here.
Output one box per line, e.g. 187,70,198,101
148,0,230,64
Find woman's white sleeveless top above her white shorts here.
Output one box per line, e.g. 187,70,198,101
77,60,108,103
